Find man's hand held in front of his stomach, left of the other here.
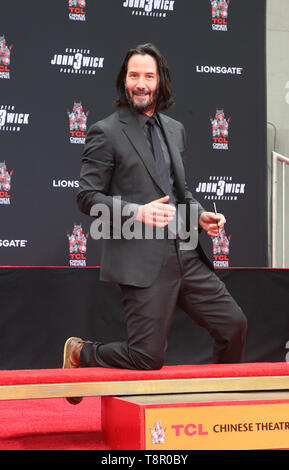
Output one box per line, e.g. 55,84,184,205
135,196,176,227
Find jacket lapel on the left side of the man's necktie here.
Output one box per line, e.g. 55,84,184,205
119,108,165,193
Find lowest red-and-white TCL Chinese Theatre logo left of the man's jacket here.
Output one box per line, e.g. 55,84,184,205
67,222,88,266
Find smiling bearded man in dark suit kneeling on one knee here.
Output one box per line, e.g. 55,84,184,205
64,44,246,402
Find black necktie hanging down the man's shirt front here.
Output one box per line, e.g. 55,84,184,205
147,117,175,205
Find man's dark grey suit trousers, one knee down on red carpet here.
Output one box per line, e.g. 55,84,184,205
81,240,247,370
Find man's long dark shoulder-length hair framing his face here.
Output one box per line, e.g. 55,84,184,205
115,43,175,111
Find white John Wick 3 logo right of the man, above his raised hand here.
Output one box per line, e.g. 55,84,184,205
195,175,246,201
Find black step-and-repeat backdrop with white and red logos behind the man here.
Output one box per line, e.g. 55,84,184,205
0,0,267,268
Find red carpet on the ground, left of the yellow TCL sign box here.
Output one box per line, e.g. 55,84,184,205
0,397,109,450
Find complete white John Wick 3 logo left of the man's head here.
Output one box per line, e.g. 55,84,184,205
50,47,104,75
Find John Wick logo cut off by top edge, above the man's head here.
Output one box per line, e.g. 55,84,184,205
122,0,175,18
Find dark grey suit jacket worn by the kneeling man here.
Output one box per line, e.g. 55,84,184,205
77,107,207,287
